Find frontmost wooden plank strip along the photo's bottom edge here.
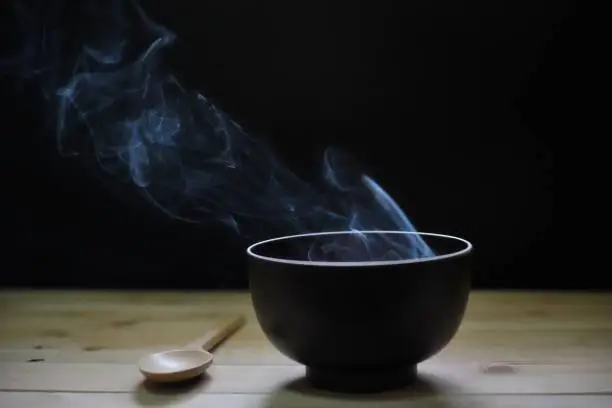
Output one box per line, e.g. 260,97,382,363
0,391,612,408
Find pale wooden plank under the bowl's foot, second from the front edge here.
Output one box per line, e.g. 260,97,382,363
0,362,612,394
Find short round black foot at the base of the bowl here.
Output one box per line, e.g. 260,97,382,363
306,366,417,393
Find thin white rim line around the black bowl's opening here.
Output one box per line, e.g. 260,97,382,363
247,231,472,267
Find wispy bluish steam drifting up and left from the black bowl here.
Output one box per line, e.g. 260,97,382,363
0,0,433,261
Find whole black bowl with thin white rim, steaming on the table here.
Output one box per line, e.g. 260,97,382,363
247,231,472,392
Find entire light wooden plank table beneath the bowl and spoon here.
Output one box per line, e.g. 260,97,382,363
0,291,612,408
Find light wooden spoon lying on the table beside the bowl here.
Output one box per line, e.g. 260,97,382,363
138,316,245,382
